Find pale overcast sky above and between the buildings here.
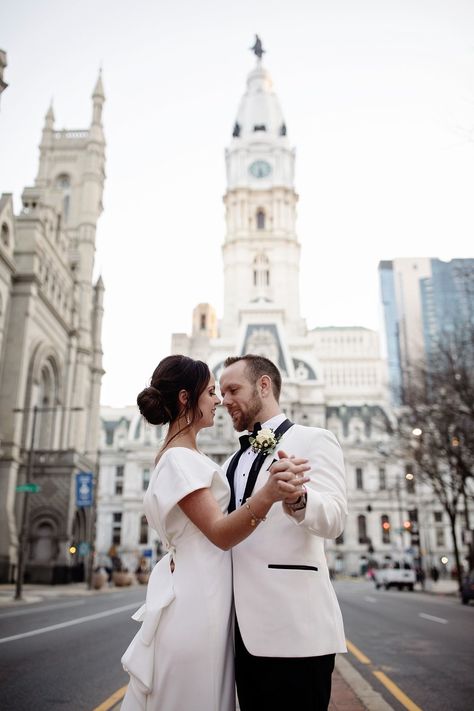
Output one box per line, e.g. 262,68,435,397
0,0,474,406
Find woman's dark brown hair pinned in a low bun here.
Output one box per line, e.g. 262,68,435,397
137,355,211,429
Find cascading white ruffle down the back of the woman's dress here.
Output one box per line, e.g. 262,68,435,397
121,553,175,695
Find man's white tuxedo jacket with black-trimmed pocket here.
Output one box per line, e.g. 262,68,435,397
224,424,347,657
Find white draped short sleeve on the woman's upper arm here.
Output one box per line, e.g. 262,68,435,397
152,447,216,521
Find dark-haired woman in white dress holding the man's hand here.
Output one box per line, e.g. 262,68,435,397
121,355,309,711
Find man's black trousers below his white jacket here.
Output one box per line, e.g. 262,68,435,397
235,619,336,711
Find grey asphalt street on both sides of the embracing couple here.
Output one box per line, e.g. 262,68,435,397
0,580,474,711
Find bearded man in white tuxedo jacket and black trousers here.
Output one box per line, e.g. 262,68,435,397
220,355,347,711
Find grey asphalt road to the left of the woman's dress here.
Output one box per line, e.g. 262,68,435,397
0,587,145,711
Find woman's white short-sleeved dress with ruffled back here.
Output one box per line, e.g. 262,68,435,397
121,447,235,711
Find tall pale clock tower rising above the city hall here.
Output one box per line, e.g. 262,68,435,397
221,48,305,338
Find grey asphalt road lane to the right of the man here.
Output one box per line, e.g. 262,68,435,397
335,581,474,711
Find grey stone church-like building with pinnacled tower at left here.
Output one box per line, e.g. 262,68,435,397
0,77,105,582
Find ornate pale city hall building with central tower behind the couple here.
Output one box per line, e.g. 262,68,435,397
97,46,460,574
